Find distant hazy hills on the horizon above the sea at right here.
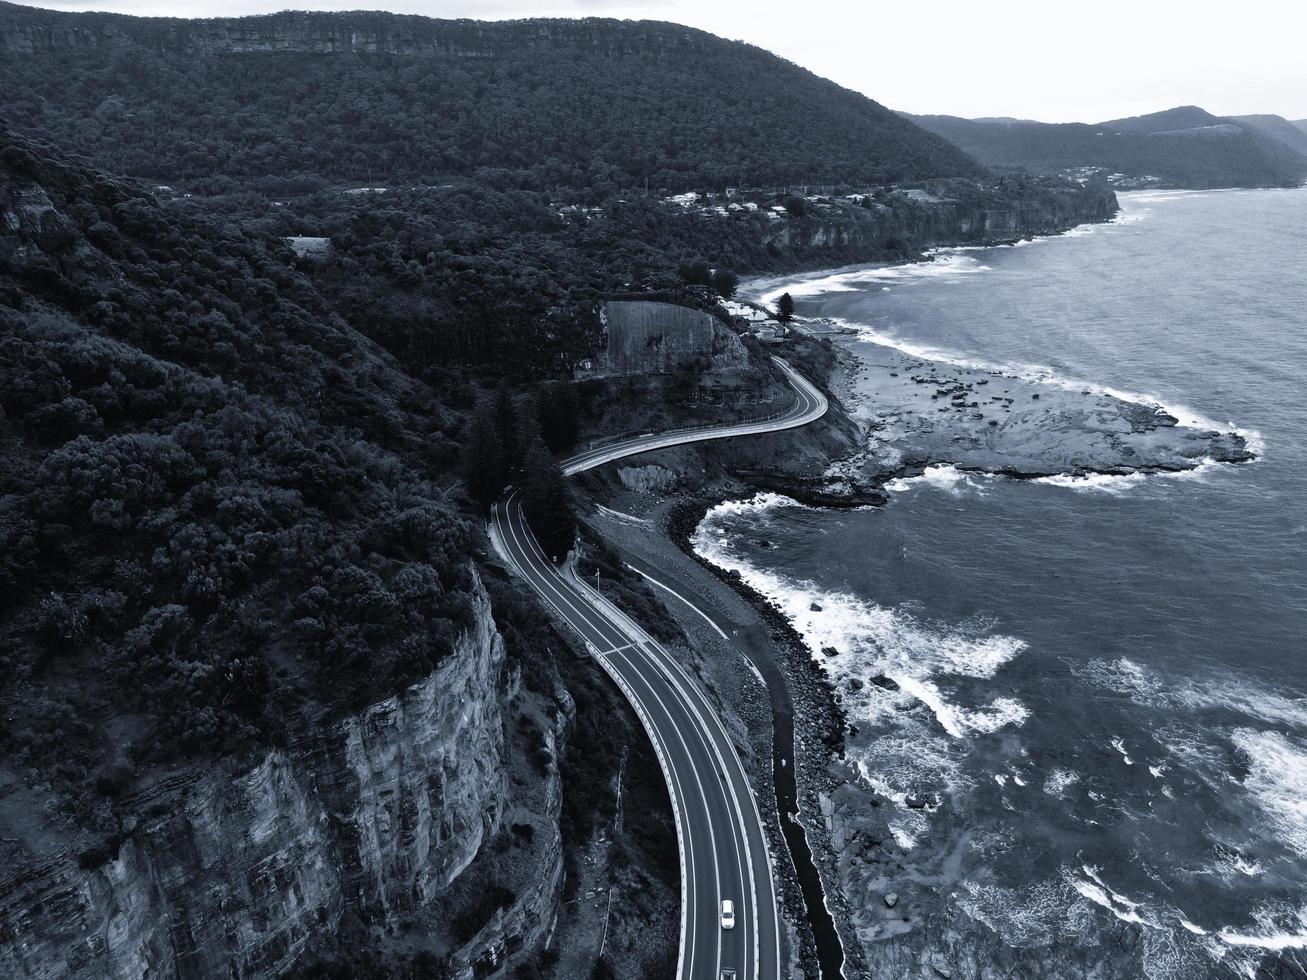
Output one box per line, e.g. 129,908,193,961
907,106,1307,188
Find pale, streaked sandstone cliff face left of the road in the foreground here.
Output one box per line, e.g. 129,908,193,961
0,572,562,977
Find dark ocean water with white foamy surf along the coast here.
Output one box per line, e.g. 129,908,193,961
697,189,1307,976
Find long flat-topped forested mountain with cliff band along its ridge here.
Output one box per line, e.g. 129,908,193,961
0,4,979,191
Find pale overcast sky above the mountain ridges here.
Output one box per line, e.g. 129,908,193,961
17,0,1307,122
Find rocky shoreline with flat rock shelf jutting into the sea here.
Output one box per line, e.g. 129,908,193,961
670,303,1256,977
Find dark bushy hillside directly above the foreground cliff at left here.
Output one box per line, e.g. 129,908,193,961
0,128,471,806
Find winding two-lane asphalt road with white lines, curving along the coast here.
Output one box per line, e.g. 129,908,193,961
490,358,827,980
